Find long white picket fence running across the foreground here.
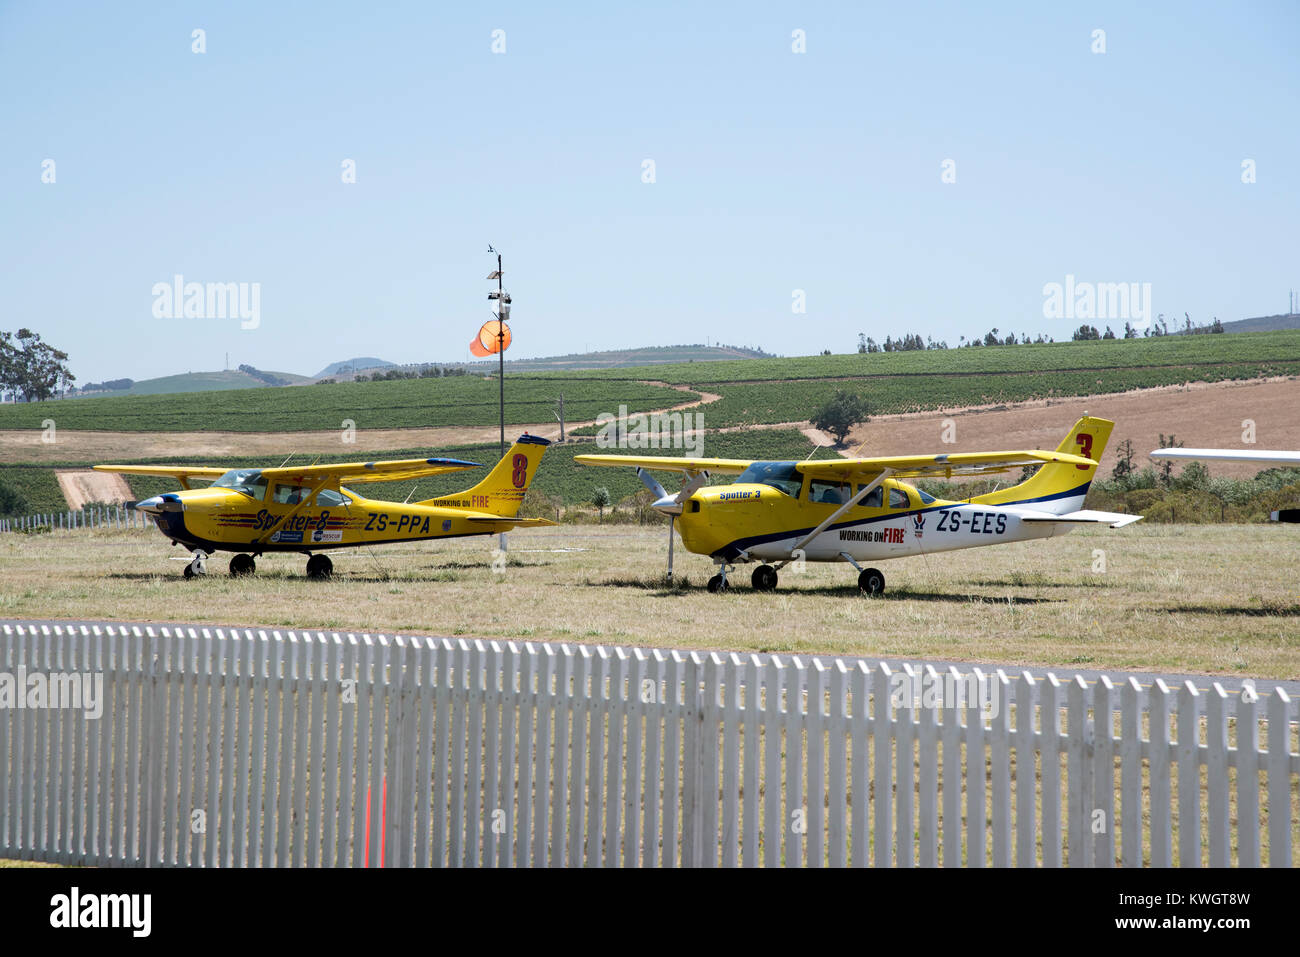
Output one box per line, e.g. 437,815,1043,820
0,623,1300,866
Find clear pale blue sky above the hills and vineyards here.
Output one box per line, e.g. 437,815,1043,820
0,1,1300,382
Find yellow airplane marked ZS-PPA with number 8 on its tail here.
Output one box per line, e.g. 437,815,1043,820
95,433,555,579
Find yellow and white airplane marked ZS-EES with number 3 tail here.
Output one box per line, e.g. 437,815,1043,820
573,415,1141,594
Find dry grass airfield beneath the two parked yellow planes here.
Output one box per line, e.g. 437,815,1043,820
0,523,1300,679
